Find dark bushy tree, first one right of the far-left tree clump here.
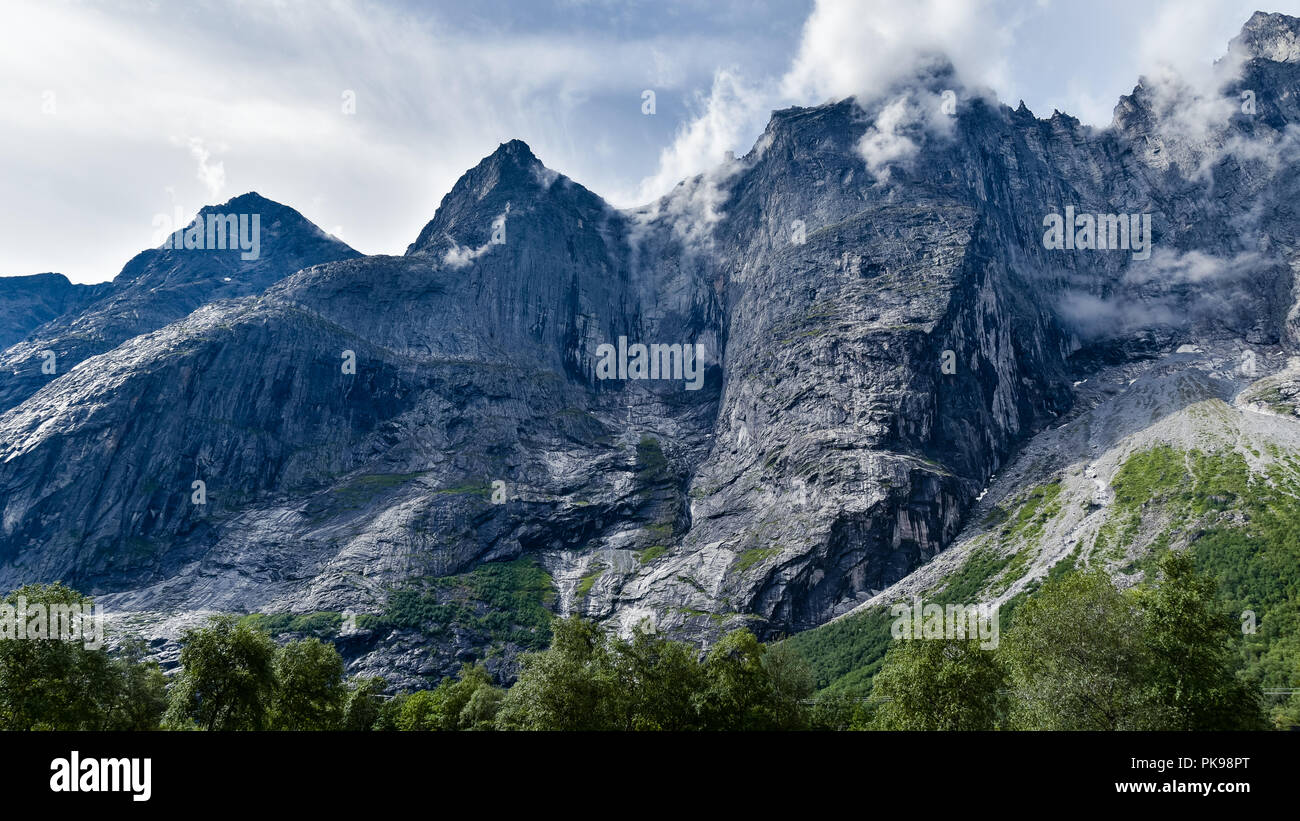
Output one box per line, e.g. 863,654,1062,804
166,614,276,730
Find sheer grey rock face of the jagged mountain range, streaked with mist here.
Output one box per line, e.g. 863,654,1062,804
0,16,1300,683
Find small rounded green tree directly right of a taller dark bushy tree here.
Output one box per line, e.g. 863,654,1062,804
270,638,347,730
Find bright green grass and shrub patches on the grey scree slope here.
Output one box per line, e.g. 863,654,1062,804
788,444,1300,694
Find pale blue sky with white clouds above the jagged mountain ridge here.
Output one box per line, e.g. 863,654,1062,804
0,0,1300,283
